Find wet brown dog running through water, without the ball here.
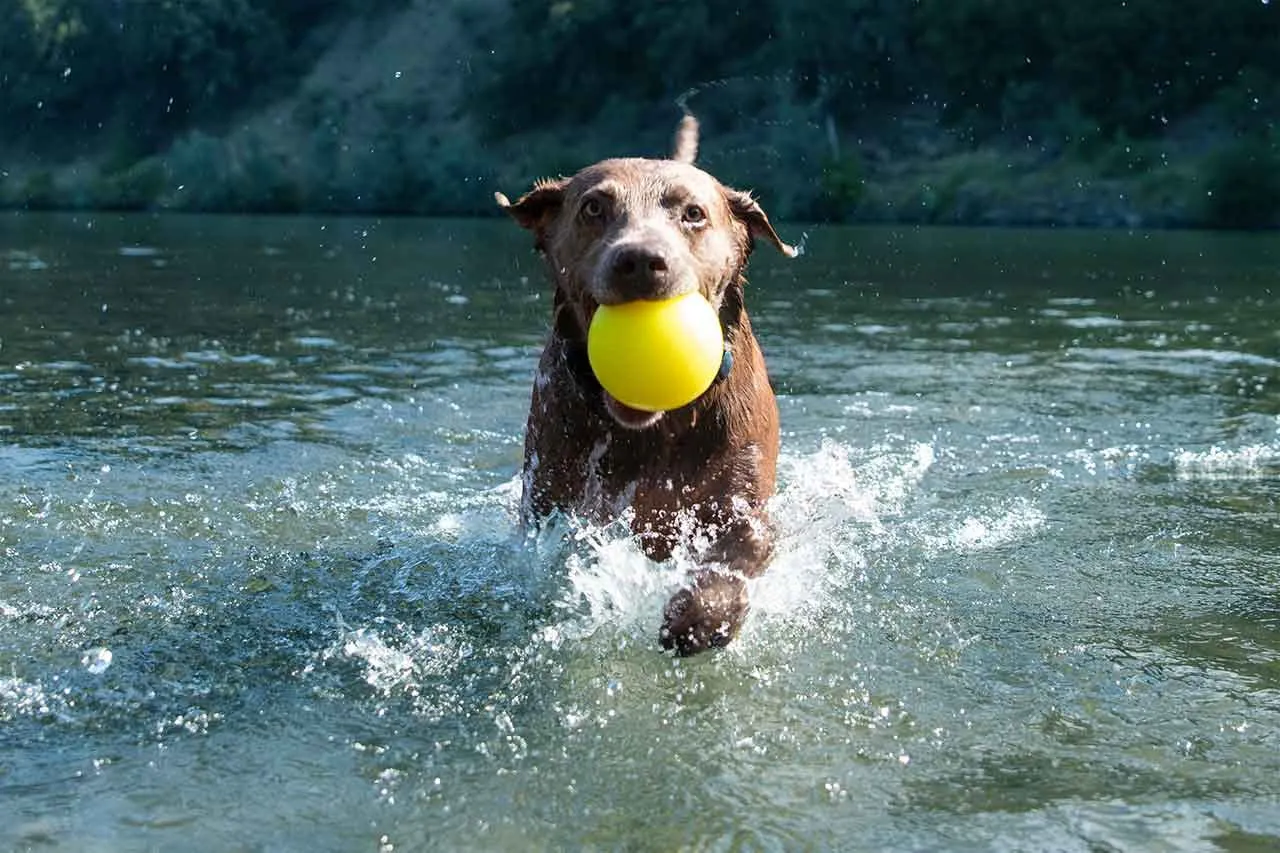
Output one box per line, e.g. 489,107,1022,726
497,117,796,654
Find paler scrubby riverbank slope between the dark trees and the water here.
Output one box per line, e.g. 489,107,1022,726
0,0,1280,227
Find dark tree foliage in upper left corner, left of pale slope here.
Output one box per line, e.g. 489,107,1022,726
0,0,368,154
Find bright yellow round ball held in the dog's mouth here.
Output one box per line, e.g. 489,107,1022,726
586,293,724,411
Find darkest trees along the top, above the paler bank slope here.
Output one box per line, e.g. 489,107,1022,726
0,0,1280,224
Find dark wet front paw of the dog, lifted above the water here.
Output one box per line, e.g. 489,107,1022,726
658,571,749,656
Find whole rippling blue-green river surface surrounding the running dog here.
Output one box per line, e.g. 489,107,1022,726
0,207,1280,852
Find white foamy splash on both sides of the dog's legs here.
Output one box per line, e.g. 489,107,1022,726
321,427,1024,719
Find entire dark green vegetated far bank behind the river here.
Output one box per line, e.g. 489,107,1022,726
0,0,1280,227
